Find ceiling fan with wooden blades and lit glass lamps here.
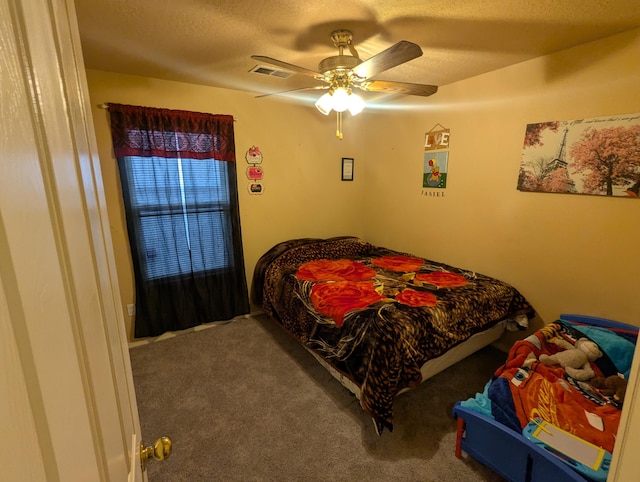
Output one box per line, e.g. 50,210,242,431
251,30,438,139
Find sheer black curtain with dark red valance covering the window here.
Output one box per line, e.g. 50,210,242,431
109,104,249,337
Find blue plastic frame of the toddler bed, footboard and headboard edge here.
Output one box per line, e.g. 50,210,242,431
453,314,638,482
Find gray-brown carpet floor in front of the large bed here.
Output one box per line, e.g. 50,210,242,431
130,317,506,482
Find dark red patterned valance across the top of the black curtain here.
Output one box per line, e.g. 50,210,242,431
109,104,236,161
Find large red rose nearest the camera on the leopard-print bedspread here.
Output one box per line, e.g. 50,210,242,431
311,281,383,327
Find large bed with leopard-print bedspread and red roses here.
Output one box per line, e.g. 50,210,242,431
251,236,534,434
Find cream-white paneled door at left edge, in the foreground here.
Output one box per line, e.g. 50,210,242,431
0,0,142,482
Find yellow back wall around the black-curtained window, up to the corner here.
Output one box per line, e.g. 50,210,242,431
87,70,365,340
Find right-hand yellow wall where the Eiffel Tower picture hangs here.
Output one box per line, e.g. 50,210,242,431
364,26,640,325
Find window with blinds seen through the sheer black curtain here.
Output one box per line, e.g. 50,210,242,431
126,156,233,280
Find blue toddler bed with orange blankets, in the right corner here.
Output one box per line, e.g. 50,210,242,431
453,314,638,482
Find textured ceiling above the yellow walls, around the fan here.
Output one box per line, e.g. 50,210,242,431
75,0,640,105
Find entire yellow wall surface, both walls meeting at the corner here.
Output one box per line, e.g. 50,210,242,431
88,30,640,342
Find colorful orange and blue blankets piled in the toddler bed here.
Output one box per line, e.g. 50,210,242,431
462,320,635,452
